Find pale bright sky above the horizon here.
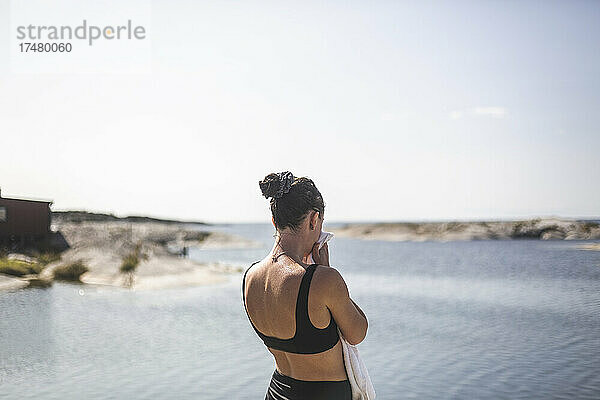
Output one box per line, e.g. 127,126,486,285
0,0,600,223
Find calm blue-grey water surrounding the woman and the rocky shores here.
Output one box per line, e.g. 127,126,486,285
0,225,600,399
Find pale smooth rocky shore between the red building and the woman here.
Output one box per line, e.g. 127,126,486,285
35,221,257,289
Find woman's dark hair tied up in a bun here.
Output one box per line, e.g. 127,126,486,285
258,171,325,230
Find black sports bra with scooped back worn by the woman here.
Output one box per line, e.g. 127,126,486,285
242,261,339,354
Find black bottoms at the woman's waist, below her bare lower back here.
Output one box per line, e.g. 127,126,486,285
265,368,352,400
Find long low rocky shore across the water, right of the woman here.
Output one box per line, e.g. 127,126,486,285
333,218,600,241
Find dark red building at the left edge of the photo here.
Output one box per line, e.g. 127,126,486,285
0,188,52,244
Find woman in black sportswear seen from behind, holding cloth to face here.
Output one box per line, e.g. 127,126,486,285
242,171,368,400
